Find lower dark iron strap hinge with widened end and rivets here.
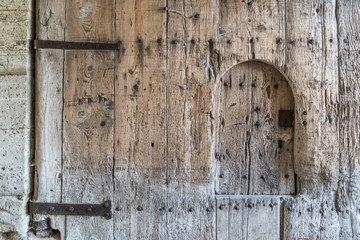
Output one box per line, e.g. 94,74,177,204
29,201,112,219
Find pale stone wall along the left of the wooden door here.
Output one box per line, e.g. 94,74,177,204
0,0,34,239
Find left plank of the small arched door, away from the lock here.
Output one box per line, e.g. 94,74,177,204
217,62,253,195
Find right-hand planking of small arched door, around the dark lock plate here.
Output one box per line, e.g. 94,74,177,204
249,62,295,194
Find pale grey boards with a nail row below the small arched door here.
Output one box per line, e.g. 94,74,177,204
217,196,286,240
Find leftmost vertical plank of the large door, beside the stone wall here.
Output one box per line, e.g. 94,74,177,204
33,0,65,239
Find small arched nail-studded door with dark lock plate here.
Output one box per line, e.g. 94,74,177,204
217,61,295,195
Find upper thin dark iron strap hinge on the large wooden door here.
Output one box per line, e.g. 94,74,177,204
34,40,122,50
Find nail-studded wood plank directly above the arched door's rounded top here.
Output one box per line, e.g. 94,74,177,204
219,0,285,71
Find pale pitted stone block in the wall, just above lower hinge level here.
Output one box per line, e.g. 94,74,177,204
0,130,32,196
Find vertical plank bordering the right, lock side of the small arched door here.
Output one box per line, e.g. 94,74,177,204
285,0,323,192
